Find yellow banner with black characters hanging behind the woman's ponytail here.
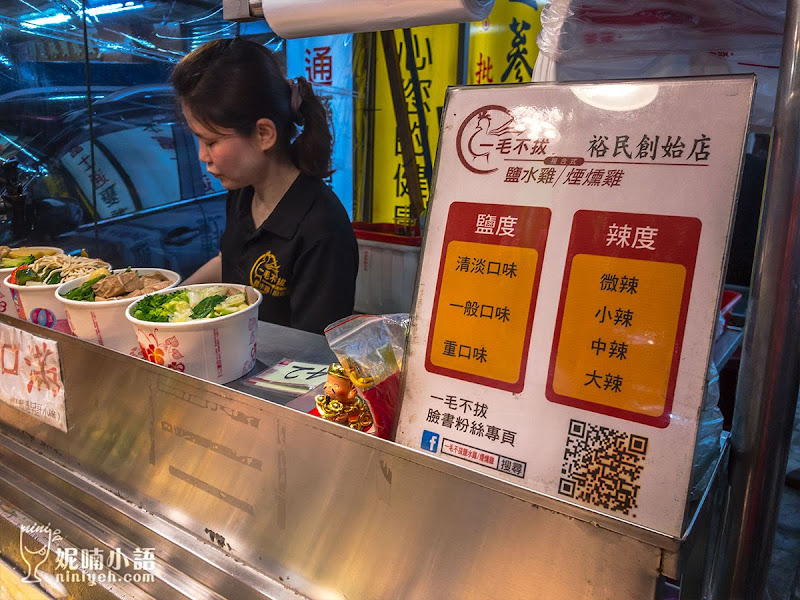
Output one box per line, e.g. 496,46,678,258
372,25,458,224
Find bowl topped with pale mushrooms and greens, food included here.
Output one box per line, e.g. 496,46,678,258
3,254,111,334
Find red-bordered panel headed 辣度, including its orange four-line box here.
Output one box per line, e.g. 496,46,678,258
546,210,701,427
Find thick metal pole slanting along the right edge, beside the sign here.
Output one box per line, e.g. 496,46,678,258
712,0,800,600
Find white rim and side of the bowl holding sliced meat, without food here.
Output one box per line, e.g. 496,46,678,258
56,268,181,354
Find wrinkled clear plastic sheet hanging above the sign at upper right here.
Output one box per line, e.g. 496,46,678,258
533,0,786,128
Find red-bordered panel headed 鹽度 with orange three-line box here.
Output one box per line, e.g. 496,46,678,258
425,202,550,392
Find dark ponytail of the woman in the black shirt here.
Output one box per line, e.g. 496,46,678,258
289,77,333,177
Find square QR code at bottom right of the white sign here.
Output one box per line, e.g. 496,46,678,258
558,419,647,517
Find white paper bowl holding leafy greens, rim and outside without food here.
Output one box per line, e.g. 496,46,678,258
125,283,262,383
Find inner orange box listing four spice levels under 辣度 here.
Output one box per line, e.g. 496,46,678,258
553,254,686,417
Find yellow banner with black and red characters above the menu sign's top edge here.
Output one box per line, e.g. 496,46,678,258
468,0,544,85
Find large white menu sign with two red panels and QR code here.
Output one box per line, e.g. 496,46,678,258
397,76,754,536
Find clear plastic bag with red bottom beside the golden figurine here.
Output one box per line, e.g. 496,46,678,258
325,313,411,439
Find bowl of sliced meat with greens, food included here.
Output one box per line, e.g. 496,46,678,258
56,268,181,354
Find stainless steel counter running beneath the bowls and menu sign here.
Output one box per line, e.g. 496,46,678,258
0,317,724,600
